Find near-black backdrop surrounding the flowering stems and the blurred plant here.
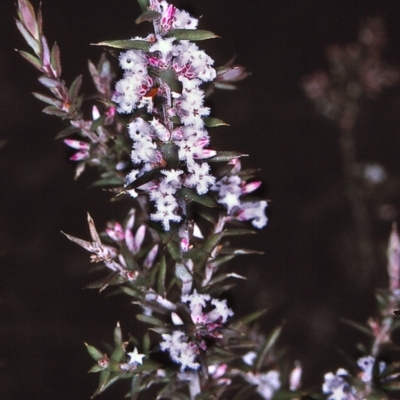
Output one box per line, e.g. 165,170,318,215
0,0,400,400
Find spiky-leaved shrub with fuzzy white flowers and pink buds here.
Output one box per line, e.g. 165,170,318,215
16,0,400,400
